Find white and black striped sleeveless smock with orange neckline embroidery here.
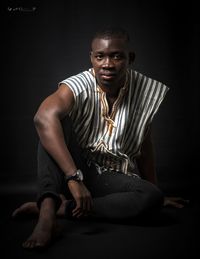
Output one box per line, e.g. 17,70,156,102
61,69,169,175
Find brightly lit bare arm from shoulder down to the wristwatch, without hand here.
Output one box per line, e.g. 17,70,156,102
34,85,77,178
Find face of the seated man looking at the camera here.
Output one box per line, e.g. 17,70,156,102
90,38,130,88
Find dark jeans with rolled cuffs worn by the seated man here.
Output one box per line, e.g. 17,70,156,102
38,118,163,219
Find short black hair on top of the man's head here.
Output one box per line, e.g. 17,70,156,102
92,27,130,42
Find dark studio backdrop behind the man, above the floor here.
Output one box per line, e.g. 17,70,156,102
0,0,200,199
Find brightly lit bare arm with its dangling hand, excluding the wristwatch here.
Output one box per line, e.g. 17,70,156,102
34,85,92,217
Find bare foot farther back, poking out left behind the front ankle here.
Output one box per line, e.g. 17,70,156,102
12,202,39,218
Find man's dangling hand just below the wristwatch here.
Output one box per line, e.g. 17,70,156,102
68,180,93,218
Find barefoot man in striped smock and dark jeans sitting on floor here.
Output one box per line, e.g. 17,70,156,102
13,26,187,248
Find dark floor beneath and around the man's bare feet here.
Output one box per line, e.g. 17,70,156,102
0,176,200,259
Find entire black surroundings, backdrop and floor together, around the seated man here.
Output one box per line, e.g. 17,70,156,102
0,0,200,259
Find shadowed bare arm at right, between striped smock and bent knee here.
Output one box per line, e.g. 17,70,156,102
137,128,157,185
